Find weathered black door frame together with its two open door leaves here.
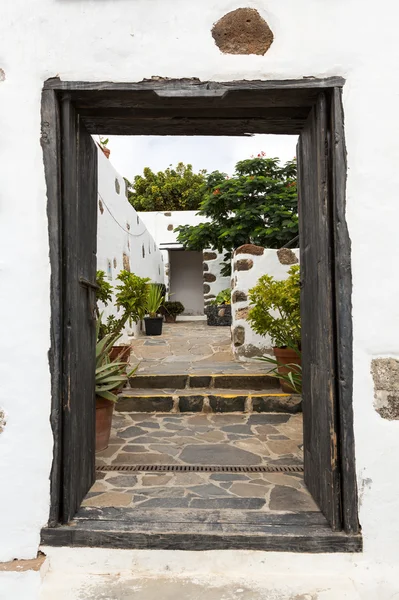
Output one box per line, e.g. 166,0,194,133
42,78,361,551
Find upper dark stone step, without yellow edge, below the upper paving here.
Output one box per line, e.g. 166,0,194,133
129,373,280,392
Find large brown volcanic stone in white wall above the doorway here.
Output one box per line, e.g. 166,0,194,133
212,8,274,54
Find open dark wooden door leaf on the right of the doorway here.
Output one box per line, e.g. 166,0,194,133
297,92,342,530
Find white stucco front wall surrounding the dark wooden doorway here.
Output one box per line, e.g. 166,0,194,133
0,0,399,600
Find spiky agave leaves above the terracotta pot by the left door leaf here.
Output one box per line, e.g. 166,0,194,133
96,322,138,402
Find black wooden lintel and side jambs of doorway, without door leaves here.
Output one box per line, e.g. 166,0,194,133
41,78,359,533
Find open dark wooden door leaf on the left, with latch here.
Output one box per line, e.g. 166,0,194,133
60,99,97,522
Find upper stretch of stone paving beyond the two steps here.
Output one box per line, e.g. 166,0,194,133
130,321,267,374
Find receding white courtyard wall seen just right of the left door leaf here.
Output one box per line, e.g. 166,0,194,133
97,149,164,343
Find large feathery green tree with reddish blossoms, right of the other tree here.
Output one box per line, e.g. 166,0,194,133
175,152,298,275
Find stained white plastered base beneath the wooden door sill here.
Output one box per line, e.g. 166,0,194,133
39,548,399,600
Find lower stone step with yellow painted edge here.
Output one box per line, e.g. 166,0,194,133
116,388,302,414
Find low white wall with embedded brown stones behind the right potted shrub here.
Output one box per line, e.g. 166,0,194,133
231,244,299,360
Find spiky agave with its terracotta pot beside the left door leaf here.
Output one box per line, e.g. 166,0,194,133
95,322,138,452
